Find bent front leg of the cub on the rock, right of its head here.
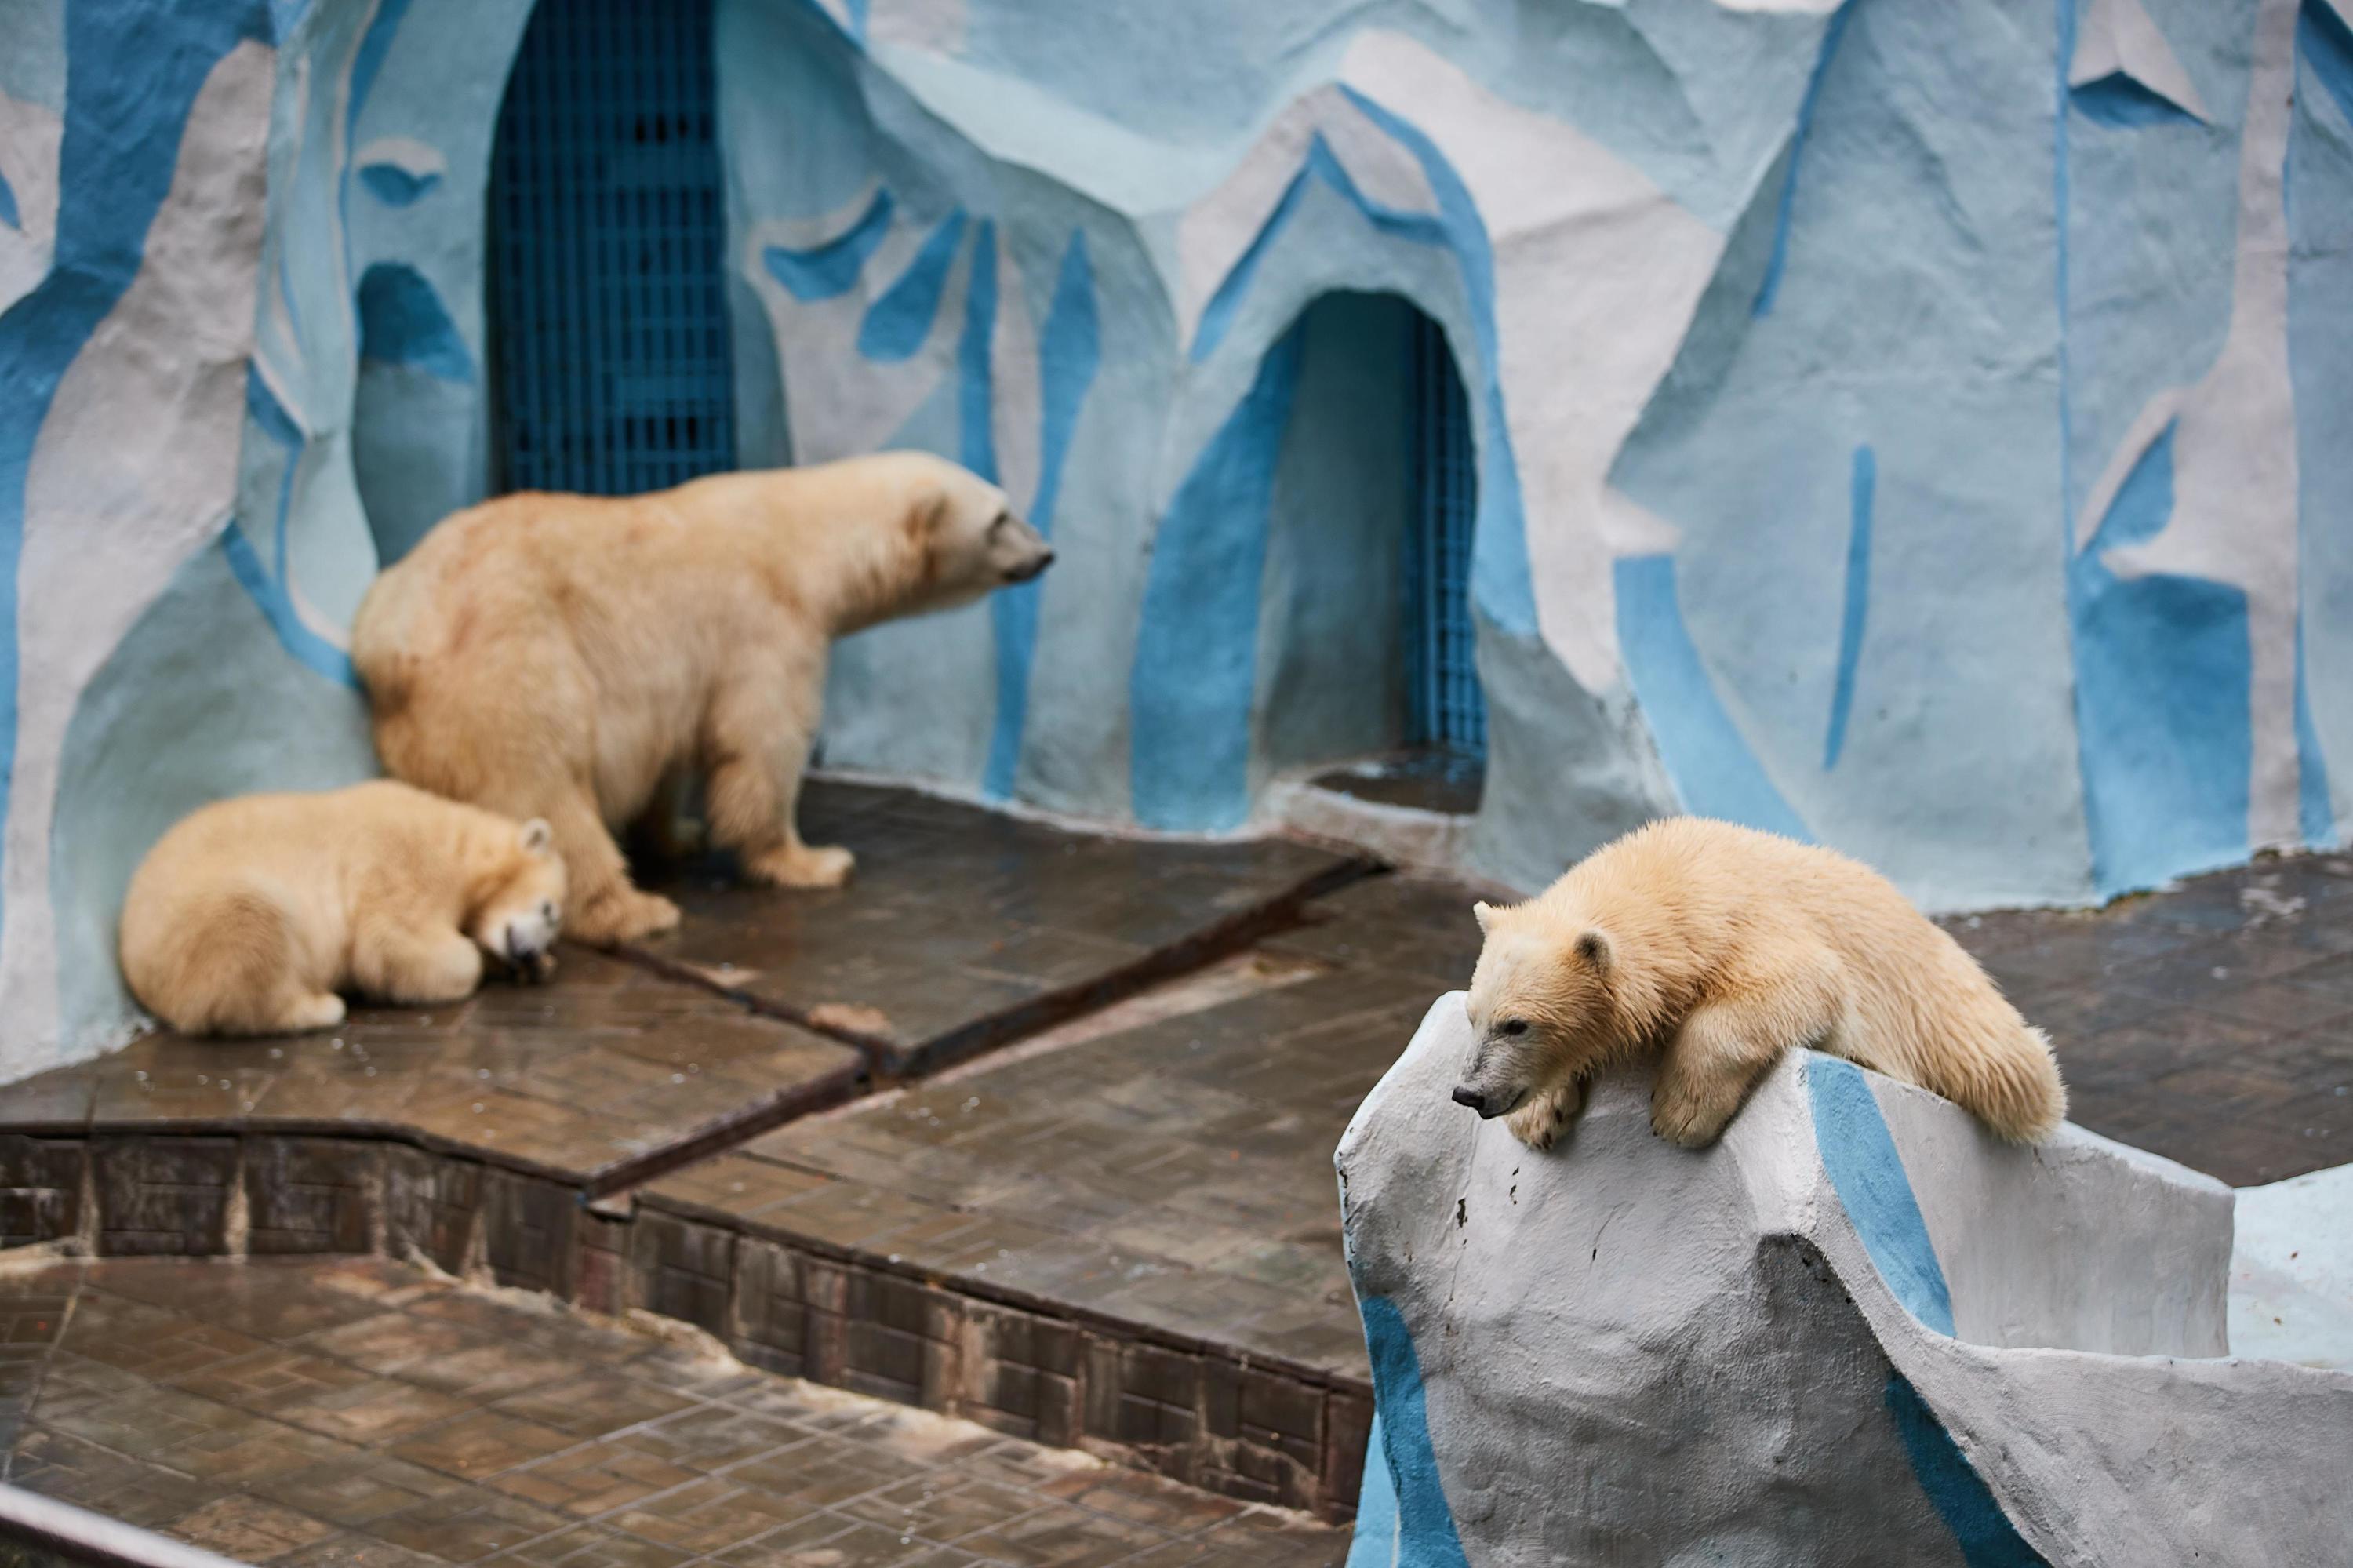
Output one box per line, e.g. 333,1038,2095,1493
1649,956,1847,1149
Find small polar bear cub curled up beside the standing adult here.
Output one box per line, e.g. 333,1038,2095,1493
122,779,565,1034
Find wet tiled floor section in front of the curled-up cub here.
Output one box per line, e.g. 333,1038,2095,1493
0,949,864,1177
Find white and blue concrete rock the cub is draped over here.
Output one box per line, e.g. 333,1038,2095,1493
1337,996,2353,1568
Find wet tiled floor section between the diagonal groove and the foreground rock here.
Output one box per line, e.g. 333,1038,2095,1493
647,876,1478,1377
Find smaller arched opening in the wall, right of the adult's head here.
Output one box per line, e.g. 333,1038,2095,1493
1259,292,1487,831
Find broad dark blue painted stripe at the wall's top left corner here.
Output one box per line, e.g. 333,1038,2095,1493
0,0,271,979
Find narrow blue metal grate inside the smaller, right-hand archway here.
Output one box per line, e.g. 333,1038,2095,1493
1405,313,1487,760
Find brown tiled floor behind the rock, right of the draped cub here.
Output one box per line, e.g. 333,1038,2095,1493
1946,855,2353,1187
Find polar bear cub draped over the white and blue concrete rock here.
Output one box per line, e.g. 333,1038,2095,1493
1454,817,2066,1149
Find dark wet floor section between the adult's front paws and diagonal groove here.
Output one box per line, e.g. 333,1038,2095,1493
638,781,1348,1071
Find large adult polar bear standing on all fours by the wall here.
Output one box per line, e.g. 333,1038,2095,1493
351,452,1054,947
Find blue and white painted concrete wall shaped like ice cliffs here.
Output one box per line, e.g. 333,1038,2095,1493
0,0,2353,1074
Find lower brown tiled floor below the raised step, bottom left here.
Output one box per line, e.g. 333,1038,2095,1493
0,1262,1348,1568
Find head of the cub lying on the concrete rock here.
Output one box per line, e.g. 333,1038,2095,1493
1454,904,1621,1116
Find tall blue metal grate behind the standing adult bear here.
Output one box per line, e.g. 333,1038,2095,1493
489,0,734,494
